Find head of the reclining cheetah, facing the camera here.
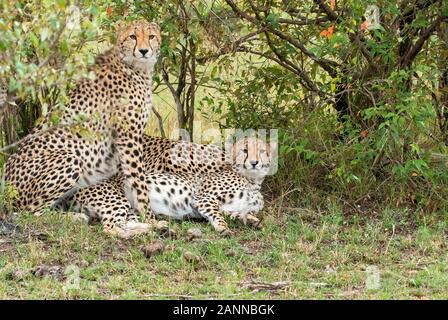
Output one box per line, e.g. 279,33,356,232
232,137,271,181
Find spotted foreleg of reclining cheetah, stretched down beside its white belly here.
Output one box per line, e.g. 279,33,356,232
194,196,233,235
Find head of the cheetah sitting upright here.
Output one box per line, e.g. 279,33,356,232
115,19,161,70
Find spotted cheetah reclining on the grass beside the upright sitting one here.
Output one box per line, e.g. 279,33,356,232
71,137,271,238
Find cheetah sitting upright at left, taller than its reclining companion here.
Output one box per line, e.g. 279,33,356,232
5,20,161,233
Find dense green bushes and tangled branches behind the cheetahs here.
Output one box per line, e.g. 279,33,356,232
0,0,448,214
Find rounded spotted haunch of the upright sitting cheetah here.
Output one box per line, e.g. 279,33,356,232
6,152,82,216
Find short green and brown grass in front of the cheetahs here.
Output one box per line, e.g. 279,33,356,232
0,201,448,299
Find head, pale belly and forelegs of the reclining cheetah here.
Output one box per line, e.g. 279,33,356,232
148,138,271,235
